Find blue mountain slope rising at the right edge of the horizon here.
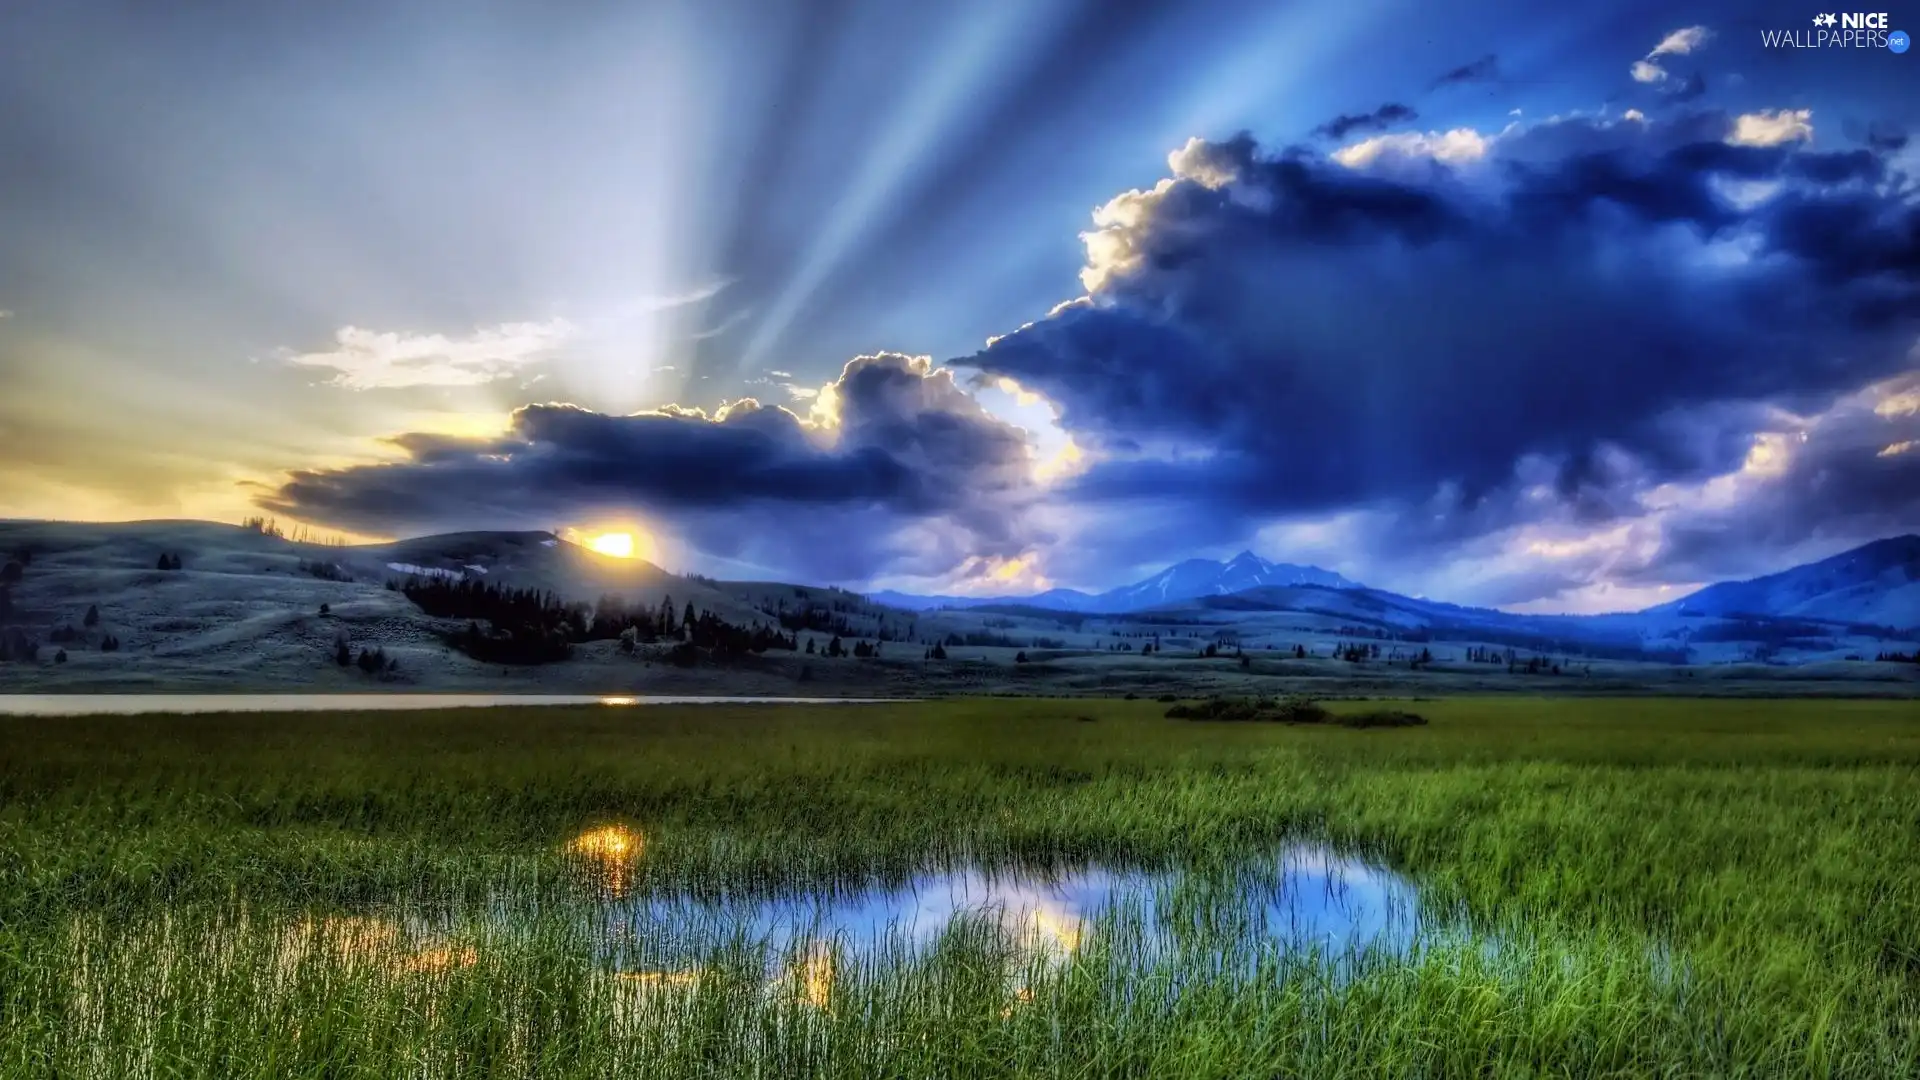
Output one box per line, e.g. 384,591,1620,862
1647,534,1920,628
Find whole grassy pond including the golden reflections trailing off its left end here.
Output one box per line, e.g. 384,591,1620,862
278,826,1430,1003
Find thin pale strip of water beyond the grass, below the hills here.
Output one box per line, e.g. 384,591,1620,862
0,694,881,717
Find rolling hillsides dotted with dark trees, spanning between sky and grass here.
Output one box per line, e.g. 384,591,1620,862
0,521,1920,696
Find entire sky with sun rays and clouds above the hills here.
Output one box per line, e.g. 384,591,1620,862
0,0,1920,611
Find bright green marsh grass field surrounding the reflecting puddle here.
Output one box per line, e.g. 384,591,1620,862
0,698,1920,1080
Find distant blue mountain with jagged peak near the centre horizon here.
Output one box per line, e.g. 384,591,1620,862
872,552,1359,615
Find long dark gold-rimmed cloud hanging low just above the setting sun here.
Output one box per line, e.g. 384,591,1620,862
259,354,1033,580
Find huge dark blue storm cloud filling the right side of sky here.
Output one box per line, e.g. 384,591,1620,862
960,113,1920,584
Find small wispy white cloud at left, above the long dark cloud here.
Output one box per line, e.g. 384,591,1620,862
284,319,574,390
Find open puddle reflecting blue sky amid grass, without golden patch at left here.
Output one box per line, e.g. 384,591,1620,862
568,826,1423,997
